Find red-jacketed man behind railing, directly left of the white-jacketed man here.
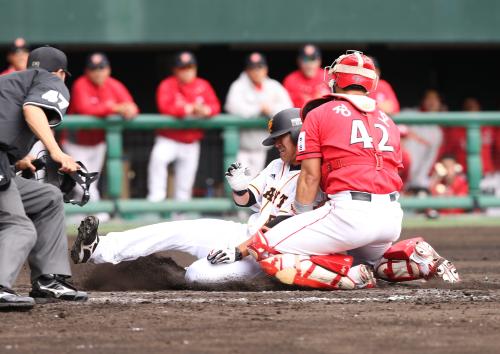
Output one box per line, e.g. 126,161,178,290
148,52,220,202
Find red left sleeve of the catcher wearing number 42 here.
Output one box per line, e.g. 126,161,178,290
297,109,321,161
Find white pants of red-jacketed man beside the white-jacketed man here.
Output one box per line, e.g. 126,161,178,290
148,136,200,202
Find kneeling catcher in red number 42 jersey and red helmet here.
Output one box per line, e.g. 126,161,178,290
209,51,459,289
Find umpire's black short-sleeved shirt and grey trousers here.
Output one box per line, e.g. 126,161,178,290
0,47,86,306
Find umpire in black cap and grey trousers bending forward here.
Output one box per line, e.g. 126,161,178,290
0,46,87,309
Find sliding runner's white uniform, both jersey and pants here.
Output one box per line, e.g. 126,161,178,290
89,159,320,283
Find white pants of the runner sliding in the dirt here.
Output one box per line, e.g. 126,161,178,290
89,219,262,283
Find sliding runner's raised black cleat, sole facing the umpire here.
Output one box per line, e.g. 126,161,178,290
71,215,99,264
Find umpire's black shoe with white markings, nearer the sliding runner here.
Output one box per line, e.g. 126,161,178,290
30,274,88,303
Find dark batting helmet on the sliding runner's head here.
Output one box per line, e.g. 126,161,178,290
262,108,302,146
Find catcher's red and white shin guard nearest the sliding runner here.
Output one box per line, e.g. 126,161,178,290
259,254,356,290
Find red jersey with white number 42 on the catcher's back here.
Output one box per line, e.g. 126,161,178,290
297,94,403,194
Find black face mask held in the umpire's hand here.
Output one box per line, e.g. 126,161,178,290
22,155,99,206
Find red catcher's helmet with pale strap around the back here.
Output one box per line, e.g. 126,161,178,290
325,50,378,92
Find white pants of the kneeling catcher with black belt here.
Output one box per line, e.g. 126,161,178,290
265,192,403,265
